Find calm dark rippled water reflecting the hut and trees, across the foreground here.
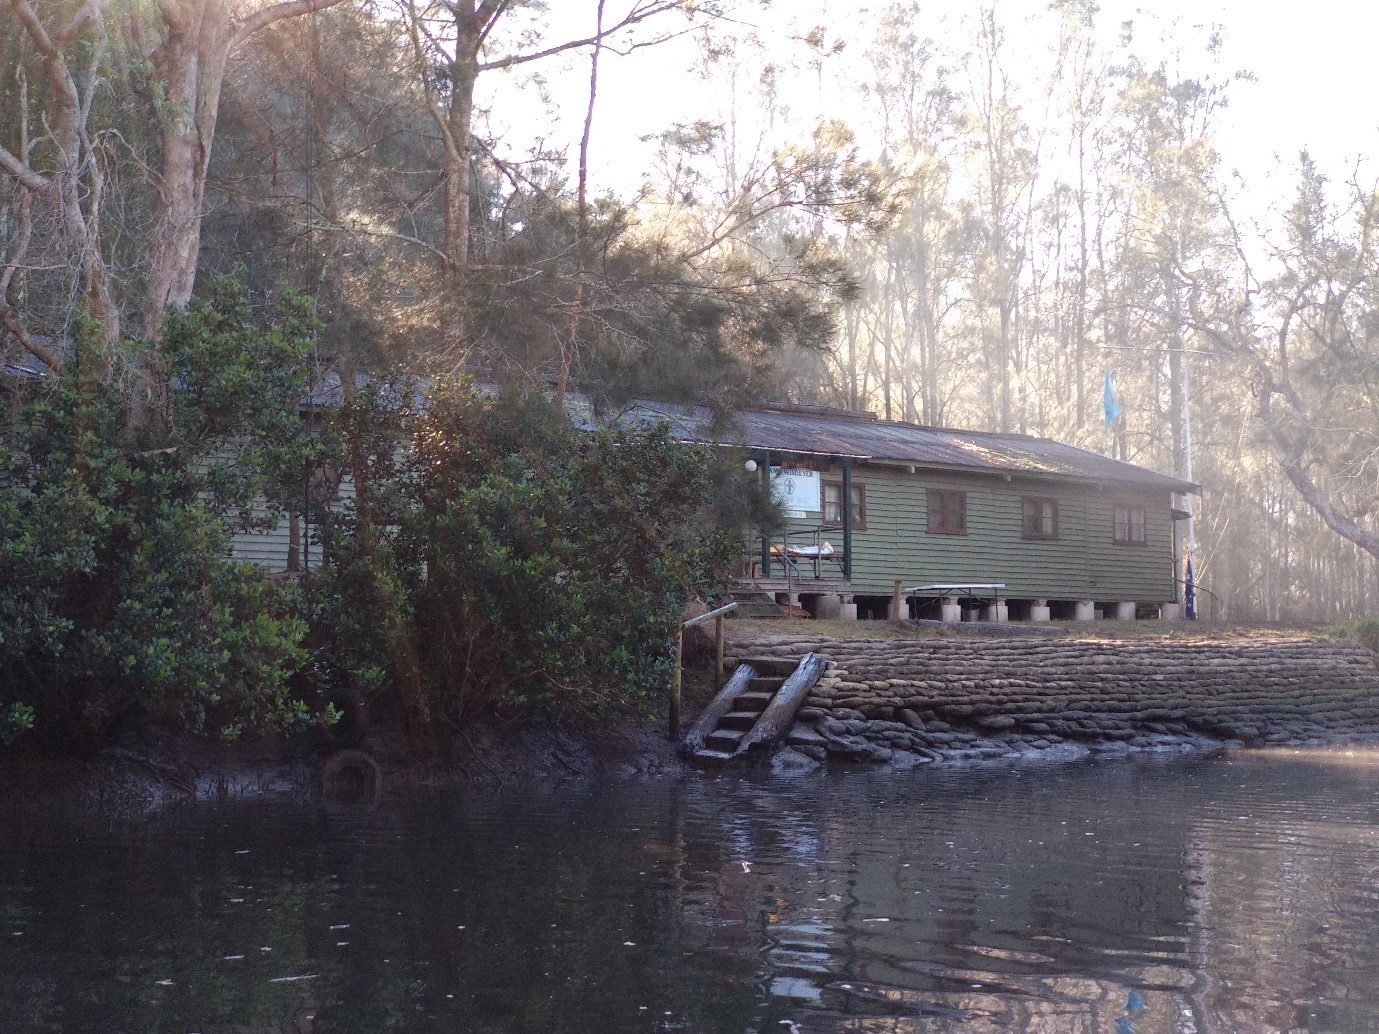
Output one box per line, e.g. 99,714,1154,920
0,756,1379,1034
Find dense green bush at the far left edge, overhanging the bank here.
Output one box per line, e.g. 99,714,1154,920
0,281,317,744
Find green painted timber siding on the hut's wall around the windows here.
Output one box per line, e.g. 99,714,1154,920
789,463,1176,602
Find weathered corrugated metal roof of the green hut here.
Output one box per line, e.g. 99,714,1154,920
587,400,1201,494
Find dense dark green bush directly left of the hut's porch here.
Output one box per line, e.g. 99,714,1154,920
319,383,756,721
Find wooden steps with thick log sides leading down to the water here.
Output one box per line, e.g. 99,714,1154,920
680,653,827,765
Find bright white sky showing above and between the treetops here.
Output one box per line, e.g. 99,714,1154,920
490,0,1379,226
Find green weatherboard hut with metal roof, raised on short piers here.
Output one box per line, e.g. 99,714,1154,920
598,401,1201,620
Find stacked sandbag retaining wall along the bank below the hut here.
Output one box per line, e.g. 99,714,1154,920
729,634,1379,764
